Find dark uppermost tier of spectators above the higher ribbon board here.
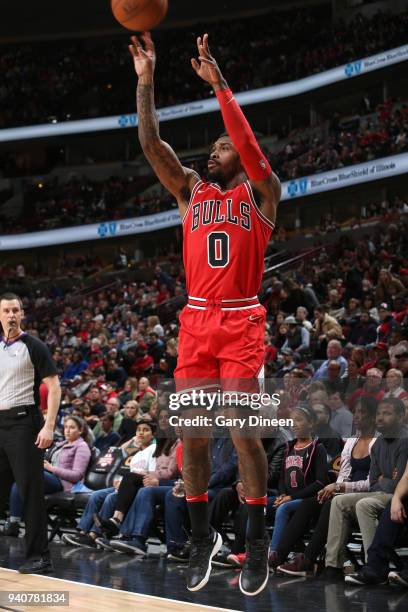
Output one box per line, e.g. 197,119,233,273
0,7,407,127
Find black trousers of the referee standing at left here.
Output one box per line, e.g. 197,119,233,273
0,406,49,560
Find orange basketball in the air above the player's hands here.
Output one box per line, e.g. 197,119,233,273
111,0,168,32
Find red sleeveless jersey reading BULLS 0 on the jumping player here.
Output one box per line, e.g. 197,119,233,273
183,181,274,299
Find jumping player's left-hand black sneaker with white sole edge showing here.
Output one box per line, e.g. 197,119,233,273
187,528,222,591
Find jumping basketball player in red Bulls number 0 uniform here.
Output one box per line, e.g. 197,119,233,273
129,32,280,595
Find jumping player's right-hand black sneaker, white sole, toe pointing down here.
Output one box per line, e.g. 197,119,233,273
239,536,269,596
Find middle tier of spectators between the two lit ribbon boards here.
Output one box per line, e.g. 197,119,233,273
0,100,408,234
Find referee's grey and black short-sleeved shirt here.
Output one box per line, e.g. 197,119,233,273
0,332,57,410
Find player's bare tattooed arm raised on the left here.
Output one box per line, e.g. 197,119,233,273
129,32,200,215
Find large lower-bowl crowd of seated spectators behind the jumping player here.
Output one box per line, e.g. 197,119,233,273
3,198,408,584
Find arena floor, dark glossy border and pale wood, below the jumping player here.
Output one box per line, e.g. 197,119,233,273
0,537,408,612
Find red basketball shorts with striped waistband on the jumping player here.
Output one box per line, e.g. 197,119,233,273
174,297,266,392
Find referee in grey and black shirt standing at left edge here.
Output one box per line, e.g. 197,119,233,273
0,293,61,574
